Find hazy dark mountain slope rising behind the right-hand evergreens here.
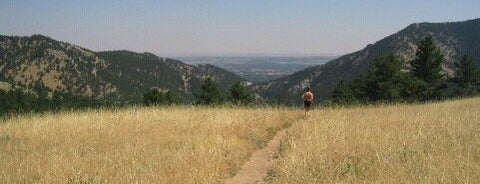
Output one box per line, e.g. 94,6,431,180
252,19,480,104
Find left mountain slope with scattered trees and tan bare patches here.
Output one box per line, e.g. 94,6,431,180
0,35,243,103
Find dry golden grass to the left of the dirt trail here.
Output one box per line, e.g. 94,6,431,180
0,107,301,183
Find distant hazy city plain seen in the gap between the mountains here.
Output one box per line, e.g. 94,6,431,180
175,56,337,83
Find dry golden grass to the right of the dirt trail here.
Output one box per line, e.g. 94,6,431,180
266,98,480,183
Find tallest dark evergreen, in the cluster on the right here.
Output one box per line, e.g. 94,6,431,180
411,36,445,100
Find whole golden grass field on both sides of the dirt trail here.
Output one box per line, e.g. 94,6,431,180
0,98,480,183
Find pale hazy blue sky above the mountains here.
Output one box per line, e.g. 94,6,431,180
0,0,480,57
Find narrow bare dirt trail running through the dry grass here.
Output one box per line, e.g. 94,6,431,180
225,129,287,184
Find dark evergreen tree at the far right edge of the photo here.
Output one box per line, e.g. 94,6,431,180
454,55,480,96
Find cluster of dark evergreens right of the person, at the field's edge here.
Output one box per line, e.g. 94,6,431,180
331,36,480,105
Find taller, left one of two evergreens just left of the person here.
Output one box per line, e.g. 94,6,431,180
195,77,223,105
